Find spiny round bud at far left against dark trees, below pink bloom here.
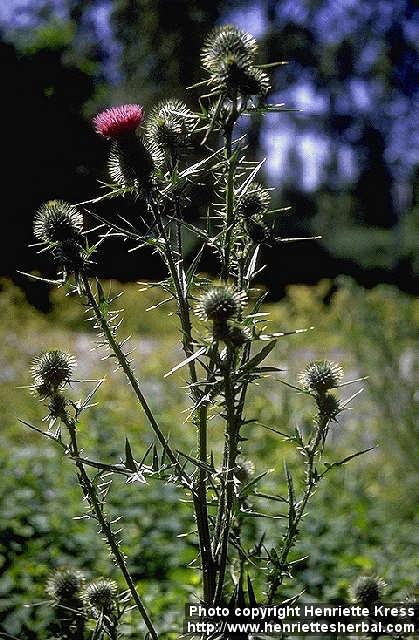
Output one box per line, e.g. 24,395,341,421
34,200,83,242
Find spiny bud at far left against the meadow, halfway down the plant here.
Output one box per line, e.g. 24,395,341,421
31,350,76,395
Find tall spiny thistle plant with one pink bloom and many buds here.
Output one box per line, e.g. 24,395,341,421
21,26,372,639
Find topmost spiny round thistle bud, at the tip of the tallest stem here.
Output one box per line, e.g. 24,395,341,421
201,25,257,73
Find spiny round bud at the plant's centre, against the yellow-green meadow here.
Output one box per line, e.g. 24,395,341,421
195,287,247,322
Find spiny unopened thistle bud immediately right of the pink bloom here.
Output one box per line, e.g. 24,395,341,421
146,99,194,161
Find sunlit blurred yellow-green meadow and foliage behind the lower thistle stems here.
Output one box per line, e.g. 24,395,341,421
0,279,419,640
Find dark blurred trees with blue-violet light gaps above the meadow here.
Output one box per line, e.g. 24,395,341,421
0,0,419,305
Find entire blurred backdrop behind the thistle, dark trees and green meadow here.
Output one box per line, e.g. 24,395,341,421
0,0,419,640
